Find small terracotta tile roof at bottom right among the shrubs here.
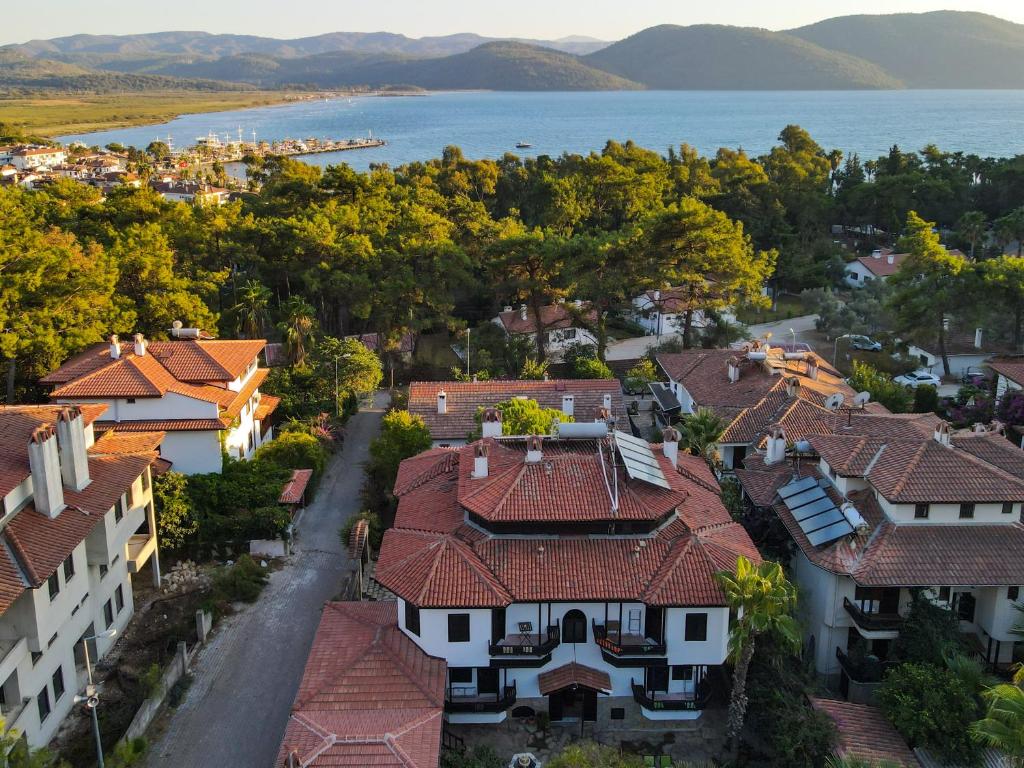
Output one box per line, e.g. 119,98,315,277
811,697,921,768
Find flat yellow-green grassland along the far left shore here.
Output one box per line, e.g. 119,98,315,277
0,91,304,136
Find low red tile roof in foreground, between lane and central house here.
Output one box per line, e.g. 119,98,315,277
275,601,446,768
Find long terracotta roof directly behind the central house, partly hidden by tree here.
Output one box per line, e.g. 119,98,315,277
409,379,626,440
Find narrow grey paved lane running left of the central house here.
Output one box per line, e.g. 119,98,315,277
148,394,386,768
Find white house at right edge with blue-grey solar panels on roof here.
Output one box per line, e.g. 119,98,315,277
736,415,1024,692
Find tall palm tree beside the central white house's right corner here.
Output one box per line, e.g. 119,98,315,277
715,555,800,756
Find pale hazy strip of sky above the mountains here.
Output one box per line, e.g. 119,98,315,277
6,0,1024,43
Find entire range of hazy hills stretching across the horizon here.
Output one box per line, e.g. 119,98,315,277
0,11,1024,90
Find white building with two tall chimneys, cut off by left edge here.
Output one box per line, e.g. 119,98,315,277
0,404,163,746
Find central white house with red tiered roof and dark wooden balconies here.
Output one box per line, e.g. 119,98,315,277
374,421,760,723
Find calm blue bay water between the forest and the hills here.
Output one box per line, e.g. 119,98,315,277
60,91,1024,170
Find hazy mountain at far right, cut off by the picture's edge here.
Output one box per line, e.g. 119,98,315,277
790,11,1024,88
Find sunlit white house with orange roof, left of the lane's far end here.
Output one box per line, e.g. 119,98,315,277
41,323,279,474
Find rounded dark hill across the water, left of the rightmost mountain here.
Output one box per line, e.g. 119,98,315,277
583,25,902,90
